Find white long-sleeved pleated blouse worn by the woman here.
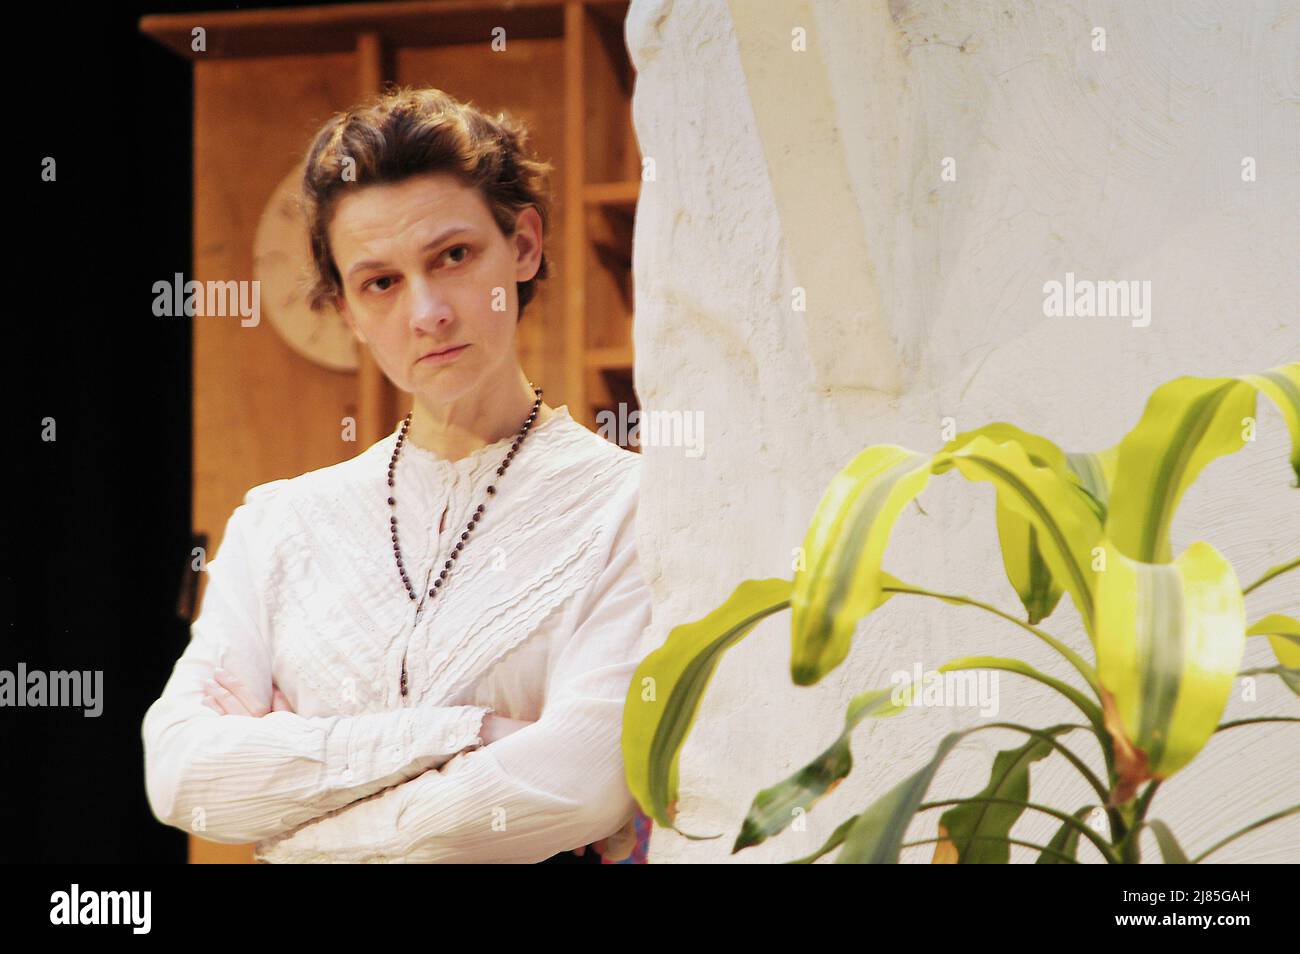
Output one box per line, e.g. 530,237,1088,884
142,406,651,863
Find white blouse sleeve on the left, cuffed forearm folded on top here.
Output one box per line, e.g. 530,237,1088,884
142,489,491,844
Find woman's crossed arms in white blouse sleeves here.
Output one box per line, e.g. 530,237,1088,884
143,493,650,862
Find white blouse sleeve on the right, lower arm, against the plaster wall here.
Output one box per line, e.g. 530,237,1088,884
257,486,651,863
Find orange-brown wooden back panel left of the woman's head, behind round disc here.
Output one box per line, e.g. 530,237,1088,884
190,48,363,862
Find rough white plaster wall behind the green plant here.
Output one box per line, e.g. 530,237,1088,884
625,0,1300,863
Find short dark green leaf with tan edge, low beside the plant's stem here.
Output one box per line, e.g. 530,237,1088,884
936,725,1074,864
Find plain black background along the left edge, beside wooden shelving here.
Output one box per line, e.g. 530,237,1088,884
0,3,356,862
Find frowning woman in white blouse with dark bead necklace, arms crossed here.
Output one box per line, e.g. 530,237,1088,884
143,90,650,863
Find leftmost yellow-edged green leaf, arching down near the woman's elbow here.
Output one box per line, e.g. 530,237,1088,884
623,578,792,838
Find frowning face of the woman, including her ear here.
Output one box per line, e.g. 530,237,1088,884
329,173,542,404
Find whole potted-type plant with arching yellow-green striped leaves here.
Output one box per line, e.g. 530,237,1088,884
623,363,1300,864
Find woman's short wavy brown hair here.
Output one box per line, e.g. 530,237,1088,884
302,87,554,318
